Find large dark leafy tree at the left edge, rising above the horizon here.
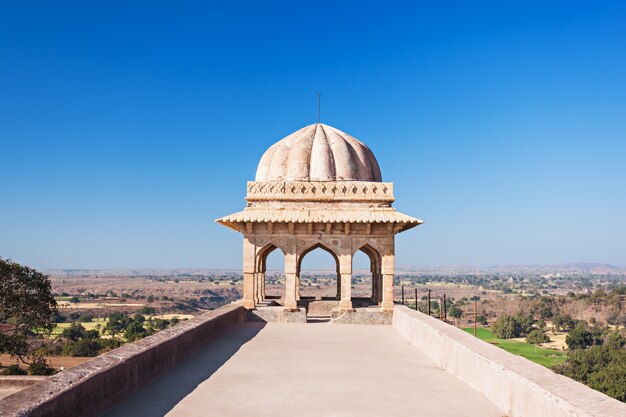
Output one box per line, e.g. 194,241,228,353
0,258,57,362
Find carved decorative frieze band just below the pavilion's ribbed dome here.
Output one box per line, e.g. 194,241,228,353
246,181,394,203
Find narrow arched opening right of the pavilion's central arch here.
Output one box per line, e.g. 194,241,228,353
352,245,382,304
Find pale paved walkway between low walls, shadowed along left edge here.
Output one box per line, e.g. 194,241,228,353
106,323,504,417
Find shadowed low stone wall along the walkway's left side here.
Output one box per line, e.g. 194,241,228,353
0,304,246,417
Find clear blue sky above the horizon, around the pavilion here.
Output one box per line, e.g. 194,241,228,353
0,1,626,269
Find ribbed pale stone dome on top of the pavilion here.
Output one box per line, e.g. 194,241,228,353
256,123,382,182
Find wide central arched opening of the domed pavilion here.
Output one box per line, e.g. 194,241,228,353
296,244,340,300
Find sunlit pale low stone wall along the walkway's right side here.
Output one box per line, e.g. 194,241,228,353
393,306,626,417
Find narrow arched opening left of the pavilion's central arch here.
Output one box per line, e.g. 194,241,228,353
257,245,285,300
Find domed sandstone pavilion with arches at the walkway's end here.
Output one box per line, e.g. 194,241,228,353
216,123,423,311
